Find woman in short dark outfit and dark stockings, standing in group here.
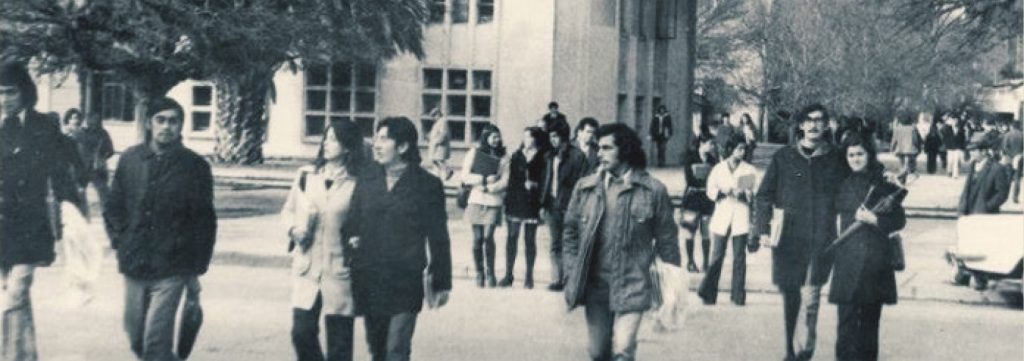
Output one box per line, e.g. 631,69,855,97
498,127,549,288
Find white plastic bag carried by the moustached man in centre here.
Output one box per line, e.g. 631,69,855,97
649,260,689,332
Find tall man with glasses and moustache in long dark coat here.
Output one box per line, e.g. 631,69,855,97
752,104,849,360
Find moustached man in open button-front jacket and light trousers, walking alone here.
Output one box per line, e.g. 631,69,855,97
564,124,680,361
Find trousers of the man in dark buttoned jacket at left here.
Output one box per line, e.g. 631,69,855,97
124,276,188,361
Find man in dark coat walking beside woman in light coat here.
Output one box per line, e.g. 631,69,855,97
342,118,452,361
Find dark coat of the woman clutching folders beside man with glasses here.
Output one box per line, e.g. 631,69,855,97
828,166,906,304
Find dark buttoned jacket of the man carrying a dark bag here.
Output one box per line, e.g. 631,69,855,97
103,144,217,279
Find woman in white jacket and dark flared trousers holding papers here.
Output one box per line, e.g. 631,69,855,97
697,137,758,306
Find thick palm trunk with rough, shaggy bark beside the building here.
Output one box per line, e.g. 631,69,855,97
214,73,272,165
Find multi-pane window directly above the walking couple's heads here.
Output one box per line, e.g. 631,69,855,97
303,62,377,140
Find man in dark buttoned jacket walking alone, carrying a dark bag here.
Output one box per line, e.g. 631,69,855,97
103,98,217,360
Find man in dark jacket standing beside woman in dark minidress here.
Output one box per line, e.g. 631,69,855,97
541,119,587,291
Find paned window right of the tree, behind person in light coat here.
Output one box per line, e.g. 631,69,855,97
420,69,493,143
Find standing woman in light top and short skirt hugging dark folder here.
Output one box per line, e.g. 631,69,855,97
462,126,509,287
